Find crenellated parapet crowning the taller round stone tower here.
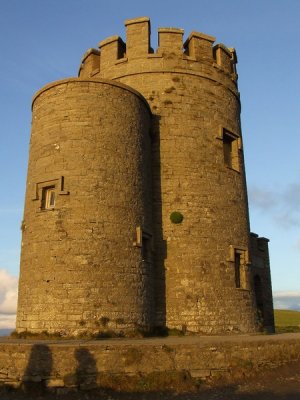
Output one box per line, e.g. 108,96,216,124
79,17,237,91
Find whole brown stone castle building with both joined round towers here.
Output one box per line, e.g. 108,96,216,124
17,18,274,334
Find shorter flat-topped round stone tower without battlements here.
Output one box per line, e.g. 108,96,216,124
17,78,153,335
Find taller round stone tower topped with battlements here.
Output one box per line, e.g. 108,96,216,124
79,18,258,333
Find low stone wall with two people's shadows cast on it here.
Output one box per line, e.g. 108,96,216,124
0,333,300,392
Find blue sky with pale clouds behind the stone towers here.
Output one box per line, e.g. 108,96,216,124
0,0,300,328
